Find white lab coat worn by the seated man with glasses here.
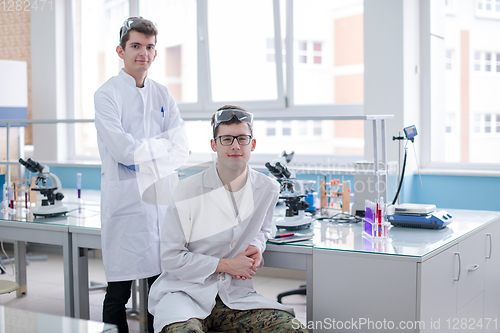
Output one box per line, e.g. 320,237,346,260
148,166,294,332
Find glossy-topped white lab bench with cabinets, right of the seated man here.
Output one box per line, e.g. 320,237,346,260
313,210,500,332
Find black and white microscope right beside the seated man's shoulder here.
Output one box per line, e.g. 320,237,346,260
265,162,313,230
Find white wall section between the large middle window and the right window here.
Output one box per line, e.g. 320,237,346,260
364,0,423,199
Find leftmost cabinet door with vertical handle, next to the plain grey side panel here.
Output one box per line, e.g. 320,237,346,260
420,245,459,333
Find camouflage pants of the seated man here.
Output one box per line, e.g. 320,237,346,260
161,296,307,333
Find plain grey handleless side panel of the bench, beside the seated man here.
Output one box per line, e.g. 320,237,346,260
313,249,418,333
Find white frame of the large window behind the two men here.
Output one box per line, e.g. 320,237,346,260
61,0,364,163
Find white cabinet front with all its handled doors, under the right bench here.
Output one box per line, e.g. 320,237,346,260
420,222,500,332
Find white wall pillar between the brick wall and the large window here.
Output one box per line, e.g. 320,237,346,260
31,0,69,161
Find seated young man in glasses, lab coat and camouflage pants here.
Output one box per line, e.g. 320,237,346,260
149,105,304,332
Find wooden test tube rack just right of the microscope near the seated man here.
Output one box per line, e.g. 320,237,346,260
320,179,351,214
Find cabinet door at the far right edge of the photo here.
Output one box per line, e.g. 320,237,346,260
484,221,500,332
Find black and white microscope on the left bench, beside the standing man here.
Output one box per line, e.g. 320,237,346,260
19,158,68,217
